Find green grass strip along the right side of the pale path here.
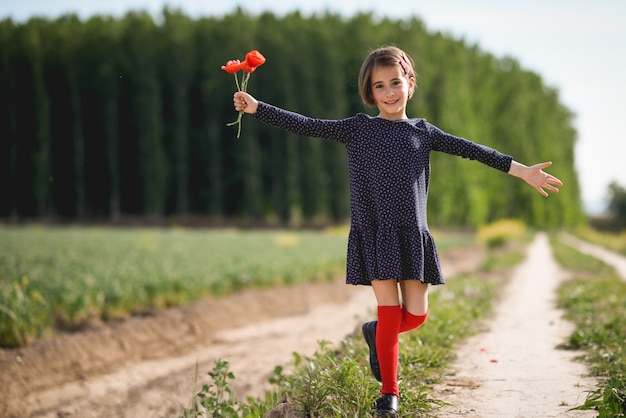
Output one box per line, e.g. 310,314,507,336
551,236,626,417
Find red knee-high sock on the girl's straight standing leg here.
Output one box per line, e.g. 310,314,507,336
376,306,402,396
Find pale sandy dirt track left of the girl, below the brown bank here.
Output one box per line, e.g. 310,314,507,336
20,283,373,418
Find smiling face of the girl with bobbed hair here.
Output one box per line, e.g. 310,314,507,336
370,65,415,120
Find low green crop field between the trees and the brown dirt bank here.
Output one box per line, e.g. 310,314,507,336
0,226,474,347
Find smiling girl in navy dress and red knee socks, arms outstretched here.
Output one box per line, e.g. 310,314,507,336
233,46,562,417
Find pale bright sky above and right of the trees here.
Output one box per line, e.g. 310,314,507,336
0,0,626,214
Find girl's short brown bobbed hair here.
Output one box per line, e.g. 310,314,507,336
359,46,417,106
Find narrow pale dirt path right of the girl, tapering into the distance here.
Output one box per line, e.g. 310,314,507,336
428,234,597,418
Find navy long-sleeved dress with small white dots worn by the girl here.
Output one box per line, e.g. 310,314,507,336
254,102,512,285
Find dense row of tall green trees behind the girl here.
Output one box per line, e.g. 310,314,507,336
0,9,583,226
